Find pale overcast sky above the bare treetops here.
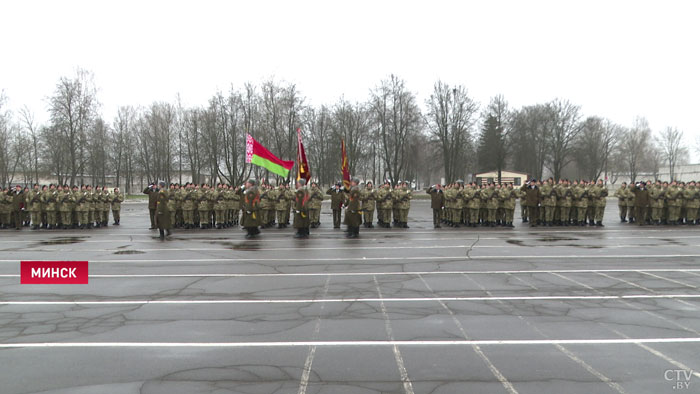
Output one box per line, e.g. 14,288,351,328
0,0,700,158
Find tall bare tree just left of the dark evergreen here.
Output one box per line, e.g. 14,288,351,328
426,81,479,182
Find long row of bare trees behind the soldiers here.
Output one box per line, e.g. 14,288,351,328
0,70,688,192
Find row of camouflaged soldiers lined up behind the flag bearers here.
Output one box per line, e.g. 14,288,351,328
143,181,412,229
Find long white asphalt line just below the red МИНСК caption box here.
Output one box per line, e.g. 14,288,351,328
0,294,700,306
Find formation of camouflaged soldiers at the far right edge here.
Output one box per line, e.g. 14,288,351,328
615,180,700,225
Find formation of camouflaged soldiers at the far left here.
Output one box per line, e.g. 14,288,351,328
0,184,124,230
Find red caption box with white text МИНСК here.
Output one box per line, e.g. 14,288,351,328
20,261,88,285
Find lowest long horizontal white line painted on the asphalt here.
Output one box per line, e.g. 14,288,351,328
0,337,700,348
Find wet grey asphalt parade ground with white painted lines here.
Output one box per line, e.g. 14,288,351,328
0,201,700,394
